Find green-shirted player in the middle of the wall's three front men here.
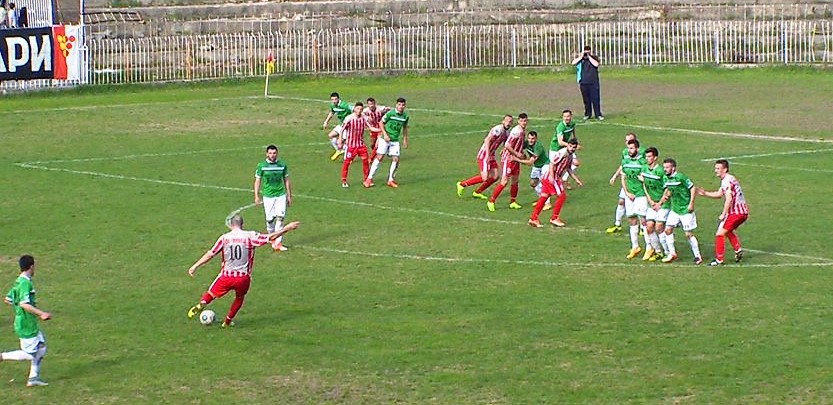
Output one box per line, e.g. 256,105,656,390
639,146,670,262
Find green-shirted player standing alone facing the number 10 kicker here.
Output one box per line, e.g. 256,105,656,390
252,145,292,252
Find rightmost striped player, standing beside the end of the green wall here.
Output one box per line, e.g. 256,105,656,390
697,159,749,266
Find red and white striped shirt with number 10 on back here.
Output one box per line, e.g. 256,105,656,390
209,229,269,277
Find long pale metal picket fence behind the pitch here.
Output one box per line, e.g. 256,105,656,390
88,20,833,84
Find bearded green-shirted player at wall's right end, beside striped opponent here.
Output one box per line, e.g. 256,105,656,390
654,158,703,264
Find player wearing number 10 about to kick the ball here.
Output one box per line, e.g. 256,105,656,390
188,214,298,327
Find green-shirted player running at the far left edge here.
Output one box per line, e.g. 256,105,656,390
0,255,52,387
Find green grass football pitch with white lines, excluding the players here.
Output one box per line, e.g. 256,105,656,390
0,68,833,404
